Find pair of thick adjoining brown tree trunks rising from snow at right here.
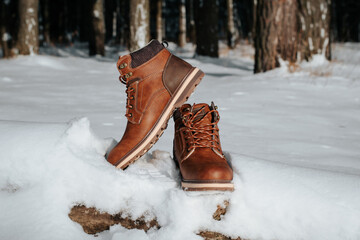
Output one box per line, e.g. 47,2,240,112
254,0,330,73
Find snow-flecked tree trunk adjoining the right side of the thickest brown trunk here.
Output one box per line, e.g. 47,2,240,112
298,0,331,61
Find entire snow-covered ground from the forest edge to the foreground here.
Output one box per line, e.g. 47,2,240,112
0,44,360,240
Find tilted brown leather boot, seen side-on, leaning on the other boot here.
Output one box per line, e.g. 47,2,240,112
107,40,204,169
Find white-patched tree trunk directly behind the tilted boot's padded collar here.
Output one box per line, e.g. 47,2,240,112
129,0,150,51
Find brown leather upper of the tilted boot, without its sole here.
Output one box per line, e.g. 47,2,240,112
107,40,197,165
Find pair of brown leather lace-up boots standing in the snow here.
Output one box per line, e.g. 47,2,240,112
107,40,234,191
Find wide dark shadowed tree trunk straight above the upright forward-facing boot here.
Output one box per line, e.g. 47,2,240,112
195,0,219,57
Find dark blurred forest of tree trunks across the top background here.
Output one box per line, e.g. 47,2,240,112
0,0,360,72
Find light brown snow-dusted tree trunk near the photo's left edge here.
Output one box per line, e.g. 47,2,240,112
16,0,39,55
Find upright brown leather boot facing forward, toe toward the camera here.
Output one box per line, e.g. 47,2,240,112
174,103,234,191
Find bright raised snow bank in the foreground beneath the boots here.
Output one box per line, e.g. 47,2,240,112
0,118,360,240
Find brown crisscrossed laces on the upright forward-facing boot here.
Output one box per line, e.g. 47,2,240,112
182,109,221,152
